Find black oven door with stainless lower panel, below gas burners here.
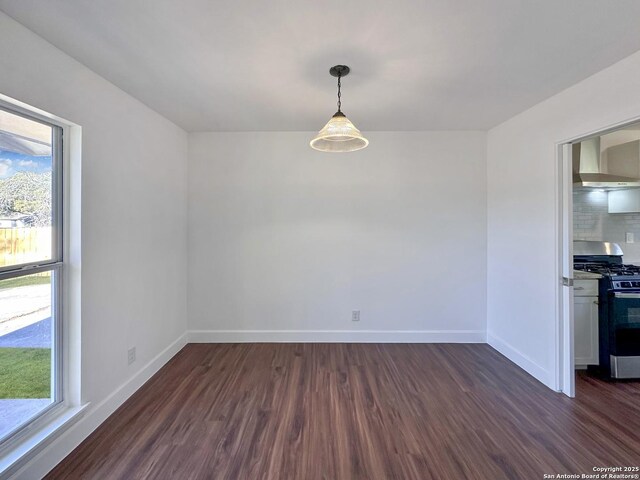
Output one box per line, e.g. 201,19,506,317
608,291,640,378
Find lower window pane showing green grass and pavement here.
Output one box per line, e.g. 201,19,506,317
0,272,55,438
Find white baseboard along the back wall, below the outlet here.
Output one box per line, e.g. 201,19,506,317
188,330,486,343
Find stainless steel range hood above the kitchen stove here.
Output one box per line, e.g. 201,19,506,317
572,137,640,189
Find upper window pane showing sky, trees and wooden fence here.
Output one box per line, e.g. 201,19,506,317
0,110,53,268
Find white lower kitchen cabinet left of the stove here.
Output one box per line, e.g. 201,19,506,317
573,294,599,366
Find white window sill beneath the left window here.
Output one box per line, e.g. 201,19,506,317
0,403,89,478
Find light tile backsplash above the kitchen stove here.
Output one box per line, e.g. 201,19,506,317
573,190,640,262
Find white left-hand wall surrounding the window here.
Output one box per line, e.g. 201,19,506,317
0,13,187,478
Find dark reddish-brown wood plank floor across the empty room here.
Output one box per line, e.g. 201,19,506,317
47,344,640,480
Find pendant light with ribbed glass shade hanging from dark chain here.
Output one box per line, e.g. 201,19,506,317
309,65,369,152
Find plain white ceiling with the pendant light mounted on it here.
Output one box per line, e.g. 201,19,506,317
0,0,640,132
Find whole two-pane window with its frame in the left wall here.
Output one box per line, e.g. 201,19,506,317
0,105,63,443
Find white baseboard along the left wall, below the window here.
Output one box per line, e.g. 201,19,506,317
11,333,187,480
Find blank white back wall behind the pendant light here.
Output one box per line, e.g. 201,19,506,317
188,132,486,342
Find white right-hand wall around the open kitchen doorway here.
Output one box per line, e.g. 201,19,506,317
487,48,640,388
